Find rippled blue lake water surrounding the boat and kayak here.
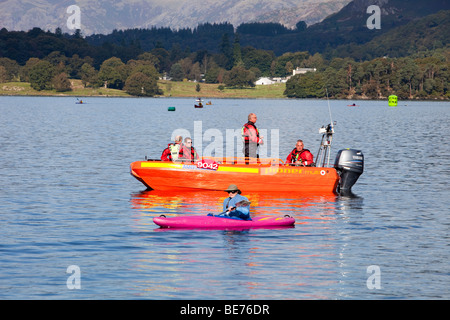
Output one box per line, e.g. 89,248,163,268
0,97,450,300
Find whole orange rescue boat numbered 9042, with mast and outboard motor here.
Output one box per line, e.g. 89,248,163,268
130,124,364,194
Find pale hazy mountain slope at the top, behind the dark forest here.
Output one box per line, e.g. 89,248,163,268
0,0,351,35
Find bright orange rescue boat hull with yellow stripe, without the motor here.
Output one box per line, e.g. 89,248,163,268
130,161,339,193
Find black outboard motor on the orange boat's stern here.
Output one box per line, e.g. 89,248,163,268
334,149,364,195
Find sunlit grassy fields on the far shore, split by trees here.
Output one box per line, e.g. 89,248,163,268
0,80,286,99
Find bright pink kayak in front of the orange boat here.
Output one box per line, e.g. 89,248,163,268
153,215,295,229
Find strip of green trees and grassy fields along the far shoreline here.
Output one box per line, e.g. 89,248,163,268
0,50,450,100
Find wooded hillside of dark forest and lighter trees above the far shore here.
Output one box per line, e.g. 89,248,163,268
0,1,450,99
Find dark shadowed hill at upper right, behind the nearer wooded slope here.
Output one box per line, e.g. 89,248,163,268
240,0,450,55
